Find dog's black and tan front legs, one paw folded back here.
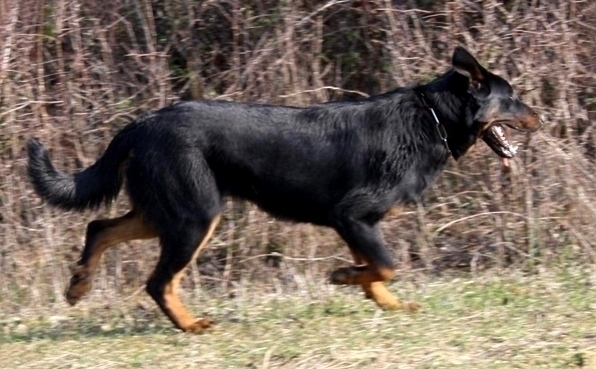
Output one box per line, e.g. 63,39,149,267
330,219,419,311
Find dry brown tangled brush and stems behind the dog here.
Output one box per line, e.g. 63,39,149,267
0,0,596,313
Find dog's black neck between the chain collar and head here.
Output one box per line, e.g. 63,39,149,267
416,71,479,160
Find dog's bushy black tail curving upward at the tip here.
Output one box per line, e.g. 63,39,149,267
27,132,131,210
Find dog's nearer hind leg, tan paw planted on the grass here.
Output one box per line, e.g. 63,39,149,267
147,215,220,333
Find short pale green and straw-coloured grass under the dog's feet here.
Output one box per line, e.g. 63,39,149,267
0,267,596,369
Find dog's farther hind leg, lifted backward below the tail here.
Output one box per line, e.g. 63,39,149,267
66,210,157,305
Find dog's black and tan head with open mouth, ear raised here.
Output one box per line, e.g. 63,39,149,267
452,47,542,159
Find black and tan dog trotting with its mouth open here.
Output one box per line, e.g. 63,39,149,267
27,47,542,332
